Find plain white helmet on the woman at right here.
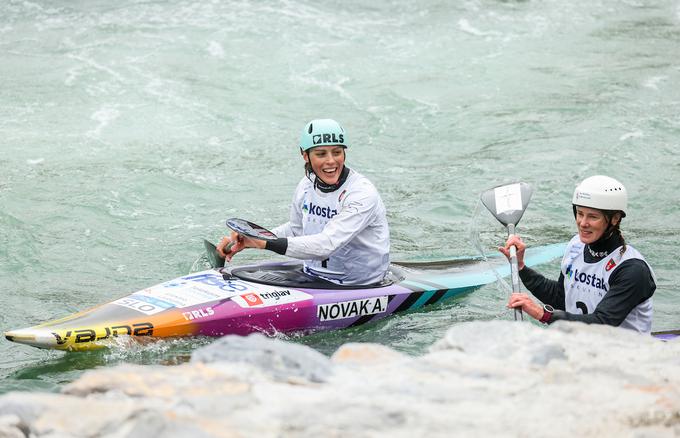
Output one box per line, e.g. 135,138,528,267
571,175,628,217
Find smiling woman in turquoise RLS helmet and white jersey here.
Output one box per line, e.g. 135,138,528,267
217,119,390,285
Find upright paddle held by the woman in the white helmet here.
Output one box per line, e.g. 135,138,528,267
481,182,532,320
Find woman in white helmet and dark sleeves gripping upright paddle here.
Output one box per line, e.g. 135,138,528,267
499,175,656,333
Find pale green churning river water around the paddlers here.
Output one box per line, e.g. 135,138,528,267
0,0,680,424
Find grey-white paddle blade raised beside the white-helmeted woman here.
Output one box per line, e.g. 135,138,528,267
481,182,533,227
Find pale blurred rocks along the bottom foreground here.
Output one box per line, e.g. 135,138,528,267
0,321,680,438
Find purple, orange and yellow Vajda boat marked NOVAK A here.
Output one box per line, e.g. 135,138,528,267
5,243,676,351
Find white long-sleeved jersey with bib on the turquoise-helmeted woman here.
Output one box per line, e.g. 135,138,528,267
272,170,390,285
